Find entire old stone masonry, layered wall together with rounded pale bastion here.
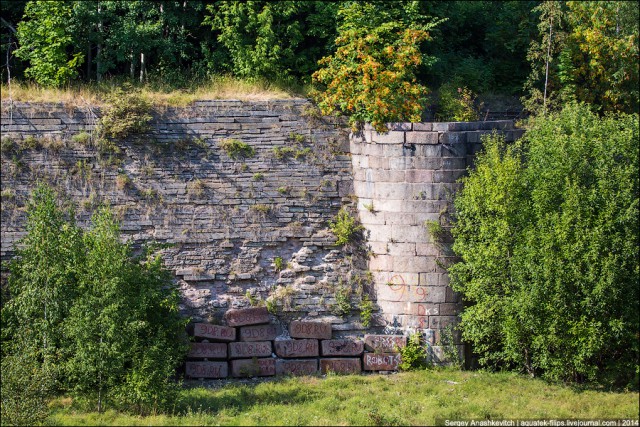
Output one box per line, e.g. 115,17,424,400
1,99,523,364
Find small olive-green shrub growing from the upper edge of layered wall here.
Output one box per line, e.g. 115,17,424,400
98,85,151,142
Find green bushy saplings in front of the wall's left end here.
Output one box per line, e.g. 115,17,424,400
2,186,187,413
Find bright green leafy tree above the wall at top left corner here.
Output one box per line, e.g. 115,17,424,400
14,1,84,87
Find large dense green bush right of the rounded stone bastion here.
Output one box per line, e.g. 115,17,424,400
449,105,640,385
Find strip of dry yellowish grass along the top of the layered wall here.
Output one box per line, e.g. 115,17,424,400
0,75,308,107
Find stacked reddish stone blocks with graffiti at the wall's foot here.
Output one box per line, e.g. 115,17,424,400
185,307,406,378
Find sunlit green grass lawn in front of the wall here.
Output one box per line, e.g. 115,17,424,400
49,369,638,426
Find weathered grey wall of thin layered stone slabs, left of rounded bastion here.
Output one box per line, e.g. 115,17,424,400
2,99,366,333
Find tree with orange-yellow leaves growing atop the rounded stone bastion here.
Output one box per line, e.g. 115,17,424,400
313,1,438,132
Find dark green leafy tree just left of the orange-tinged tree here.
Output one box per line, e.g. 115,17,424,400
204,1,338,78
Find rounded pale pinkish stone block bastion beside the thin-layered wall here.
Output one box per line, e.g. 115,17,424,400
350,120,523,357
